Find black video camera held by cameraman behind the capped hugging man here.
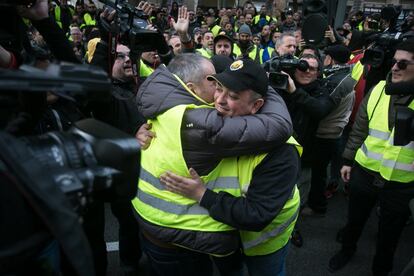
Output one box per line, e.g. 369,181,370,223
262,55,309,90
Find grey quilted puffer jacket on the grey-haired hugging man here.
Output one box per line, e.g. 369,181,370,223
137,65,292,175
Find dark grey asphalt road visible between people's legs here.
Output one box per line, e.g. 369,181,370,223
106,192,414,276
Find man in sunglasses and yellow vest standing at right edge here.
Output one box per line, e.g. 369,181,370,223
329,39,414,275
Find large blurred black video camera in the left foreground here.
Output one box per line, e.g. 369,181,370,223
0,64,140,275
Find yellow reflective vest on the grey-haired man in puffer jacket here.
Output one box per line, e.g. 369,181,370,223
132,105,240,232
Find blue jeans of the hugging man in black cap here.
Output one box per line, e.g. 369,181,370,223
244,243,289,276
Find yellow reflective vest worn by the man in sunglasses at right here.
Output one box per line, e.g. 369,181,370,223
355,81,414,183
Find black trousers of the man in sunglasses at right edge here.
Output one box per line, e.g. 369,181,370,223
342,164,414,275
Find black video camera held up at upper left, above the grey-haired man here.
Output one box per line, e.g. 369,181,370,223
99,0,162,52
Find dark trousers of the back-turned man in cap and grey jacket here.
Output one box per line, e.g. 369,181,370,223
308,138,339,213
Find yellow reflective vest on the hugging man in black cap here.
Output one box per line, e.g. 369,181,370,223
239,137,302,256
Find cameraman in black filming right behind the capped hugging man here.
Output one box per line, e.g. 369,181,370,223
281,55,337,247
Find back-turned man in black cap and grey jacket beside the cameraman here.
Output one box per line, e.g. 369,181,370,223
302,45,355,214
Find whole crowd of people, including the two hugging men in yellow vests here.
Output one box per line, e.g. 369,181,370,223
0,0,414,276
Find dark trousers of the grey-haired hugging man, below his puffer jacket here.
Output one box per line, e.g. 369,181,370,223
142,235,243,276
